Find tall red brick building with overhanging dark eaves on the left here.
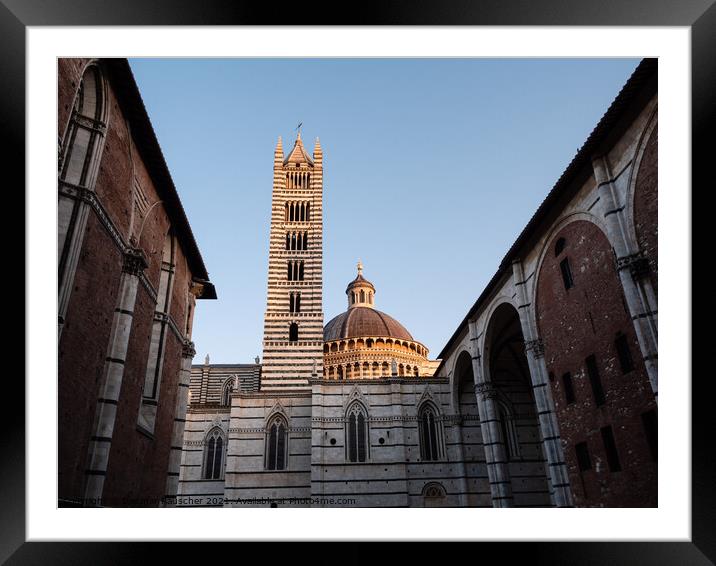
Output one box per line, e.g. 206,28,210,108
57,58,216,506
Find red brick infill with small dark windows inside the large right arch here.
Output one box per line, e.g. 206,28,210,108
536,221,657,507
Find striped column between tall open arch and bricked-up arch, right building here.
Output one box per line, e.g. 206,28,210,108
512,260,574,507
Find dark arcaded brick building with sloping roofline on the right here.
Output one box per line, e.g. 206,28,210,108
437,59,658,507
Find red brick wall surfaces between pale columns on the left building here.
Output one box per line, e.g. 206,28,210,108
58,59,199,506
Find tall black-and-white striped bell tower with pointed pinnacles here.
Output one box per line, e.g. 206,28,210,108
261,131,323,391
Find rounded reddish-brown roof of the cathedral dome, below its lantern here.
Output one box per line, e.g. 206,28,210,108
323,306,413,342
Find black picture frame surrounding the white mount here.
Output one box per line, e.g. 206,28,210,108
5,0,716,565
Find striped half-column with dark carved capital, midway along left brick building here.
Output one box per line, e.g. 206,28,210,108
84,249,148,507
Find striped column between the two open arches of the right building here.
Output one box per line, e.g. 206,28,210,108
468,321,514,507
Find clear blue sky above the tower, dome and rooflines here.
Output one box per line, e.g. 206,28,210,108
130,59,638,363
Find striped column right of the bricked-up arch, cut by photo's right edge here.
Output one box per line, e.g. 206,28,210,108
592,157,659,396
